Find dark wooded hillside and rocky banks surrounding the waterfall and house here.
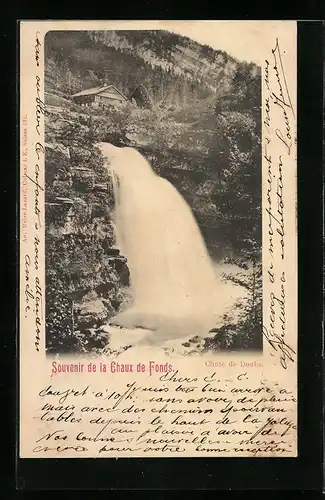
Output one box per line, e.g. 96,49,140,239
45,32,262,354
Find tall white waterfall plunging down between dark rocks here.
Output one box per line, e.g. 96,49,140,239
99,143,227,343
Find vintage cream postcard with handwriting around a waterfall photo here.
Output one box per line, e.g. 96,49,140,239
19,20,298,458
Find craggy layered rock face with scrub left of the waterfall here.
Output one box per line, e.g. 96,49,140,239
45,116,133,353
